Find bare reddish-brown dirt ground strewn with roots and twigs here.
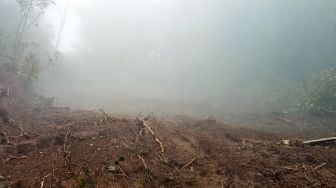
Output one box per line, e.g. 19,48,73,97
0,108,336,188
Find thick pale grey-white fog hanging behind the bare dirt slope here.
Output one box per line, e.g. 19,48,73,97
36,0,336,116
